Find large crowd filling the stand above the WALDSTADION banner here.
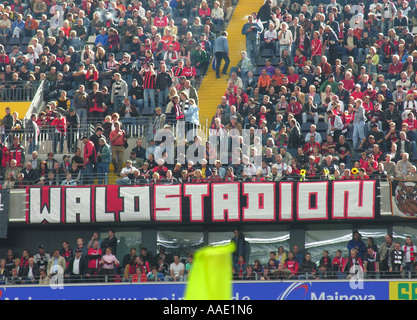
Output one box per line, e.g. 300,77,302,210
0,0,417,188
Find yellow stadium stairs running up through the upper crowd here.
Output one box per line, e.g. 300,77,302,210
198,0,264,119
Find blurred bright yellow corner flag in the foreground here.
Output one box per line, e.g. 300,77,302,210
185,242,236,300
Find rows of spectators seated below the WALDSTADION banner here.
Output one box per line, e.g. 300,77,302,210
0,229,417,285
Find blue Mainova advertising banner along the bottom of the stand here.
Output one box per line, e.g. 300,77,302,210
0,281,389,300
